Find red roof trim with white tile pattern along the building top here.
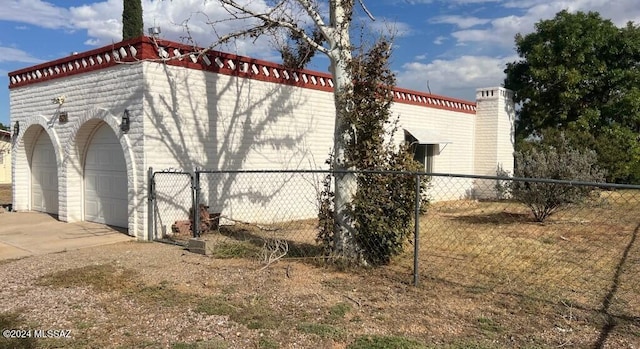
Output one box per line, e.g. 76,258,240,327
9,36,476,114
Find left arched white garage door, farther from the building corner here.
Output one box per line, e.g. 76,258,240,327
31,132,58,215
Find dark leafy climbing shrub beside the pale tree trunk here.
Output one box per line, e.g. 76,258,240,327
319,40,424,265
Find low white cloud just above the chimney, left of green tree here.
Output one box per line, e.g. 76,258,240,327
397,56,516,100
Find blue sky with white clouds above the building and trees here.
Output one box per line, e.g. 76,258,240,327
0,0,640,125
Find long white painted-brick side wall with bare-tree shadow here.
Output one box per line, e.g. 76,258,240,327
144,63,490,226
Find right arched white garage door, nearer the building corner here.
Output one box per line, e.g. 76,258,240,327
84,125,128,227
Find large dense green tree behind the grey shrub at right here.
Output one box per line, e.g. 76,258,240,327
505,11,640,182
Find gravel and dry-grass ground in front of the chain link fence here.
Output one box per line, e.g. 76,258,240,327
0,237,640,349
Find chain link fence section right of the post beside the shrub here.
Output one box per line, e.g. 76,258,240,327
419,177,640,317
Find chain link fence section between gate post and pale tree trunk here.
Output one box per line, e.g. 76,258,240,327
198,172,326,263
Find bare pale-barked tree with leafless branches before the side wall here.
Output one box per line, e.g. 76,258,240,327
195,0,373,259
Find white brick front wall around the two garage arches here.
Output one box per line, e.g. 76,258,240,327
10,65,146,237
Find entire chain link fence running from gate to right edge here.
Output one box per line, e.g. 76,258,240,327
148,171,640,317
